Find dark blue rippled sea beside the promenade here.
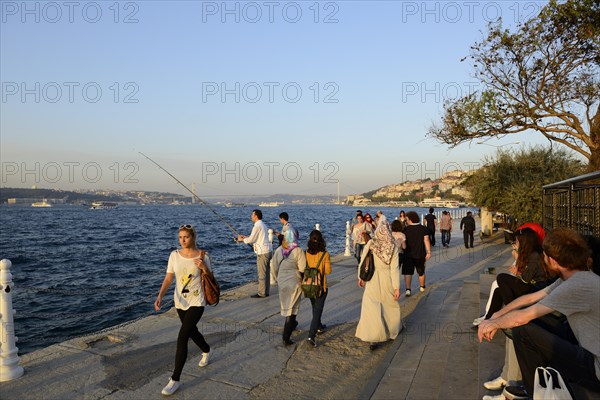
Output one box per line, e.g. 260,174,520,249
0,204,464,354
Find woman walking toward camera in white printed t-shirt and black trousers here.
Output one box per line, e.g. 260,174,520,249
154,225,211,396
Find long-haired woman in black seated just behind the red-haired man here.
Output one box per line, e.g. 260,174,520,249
485,228,551,319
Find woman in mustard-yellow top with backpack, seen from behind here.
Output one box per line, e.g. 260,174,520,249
306,229,331,347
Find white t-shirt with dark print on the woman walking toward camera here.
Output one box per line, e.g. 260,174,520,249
167,250,210,310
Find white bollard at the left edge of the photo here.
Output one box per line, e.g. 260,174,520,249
0,259,23,382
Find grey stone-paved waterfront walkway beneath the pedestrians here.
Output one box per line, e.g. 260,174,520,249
0,233,510,400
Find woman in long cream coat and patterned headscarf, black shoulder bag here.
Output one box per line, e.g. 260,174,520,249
356,221,402,350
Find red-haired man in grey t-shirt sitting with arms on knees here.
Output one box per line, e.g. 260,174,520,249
478,228,600,399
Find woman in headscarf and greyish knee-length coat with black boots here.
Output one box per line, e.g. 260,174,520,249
273,229,306,346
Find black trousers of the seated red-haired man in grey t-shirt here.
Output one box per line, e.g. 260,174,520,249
512,314,600,395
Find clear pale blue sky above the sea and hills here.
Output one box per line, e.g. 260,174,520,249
0,1,560,197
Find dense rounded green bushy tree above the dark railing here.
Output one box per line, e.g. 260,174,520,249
464,146,584,223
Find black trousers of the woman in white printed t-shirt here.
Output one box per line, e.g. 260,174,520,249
171,307,210,381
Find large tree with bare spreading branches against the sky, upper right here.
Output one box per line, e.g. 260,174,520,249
428,0,600,171
